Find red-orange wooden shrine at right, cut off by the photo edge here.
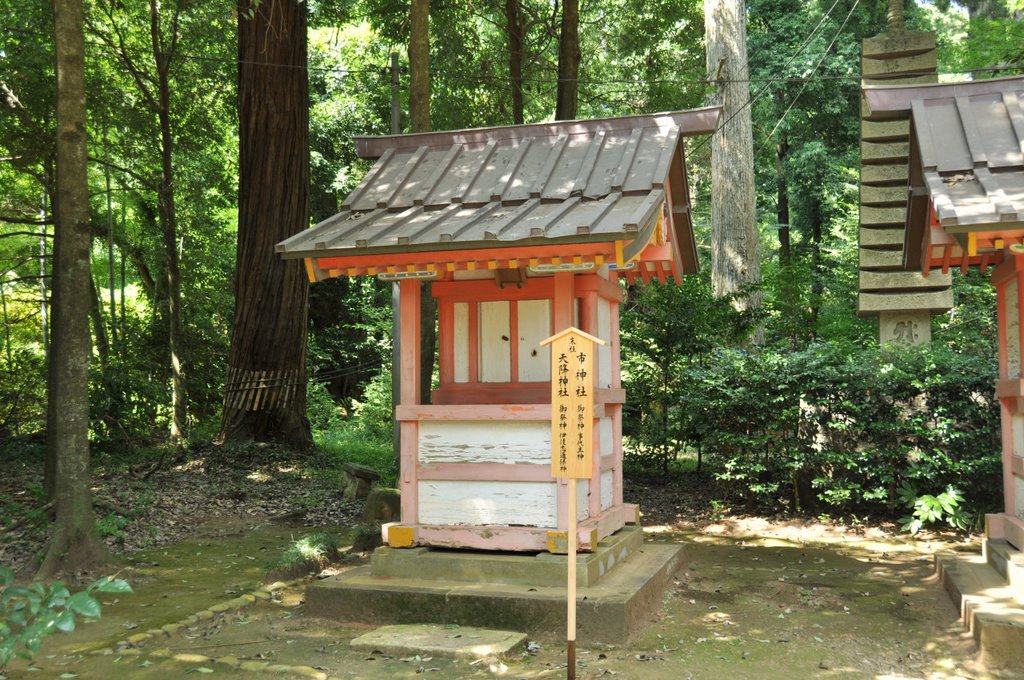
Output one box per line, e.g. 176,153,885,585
864,77,1024,550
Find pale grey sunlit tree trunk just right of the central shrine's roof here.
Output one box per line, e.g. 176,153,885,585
705,0,762,335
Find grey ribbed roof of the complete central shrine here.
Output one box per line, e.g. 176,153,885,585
278,108,721,268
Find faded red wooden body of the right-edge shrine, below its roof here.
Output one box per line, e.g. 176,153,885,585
985,253,1024,550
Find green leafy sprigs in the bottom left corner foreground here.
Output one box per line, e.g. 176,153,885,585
0,566,132,669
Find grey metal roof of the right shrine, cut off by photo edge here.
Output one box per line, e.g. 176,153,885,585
864,77,1024,268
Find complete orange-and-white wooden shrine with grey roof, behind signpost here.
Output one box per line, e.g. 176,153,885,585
278,109,720,552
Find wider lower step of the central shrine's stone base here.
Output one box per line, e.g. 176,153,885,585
305,543,685,644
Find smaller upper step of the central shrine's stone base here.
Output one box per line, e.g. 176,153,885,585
370,526,643,588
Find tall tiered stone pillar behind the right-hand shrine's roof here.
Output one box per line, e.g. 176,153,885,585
857,31,953,344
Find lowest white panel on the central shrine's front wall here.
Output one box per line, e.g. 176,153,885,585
419,480,558,527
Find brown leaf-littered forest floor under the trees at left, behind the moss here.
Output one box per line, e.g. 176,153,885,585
0,445,362,572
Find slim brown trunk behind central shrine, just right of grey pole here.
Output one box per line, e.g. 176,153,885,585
405,0,437,403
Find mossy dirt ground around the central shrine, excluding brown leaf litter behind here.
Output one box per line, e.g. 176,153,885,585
5,517,1007,680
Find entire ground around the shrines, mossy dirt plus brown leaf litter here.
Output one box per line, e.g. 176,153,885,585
0,448,1003,680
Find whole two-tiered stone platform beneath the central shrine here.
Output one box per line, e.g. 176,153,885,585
305,526,684,643
